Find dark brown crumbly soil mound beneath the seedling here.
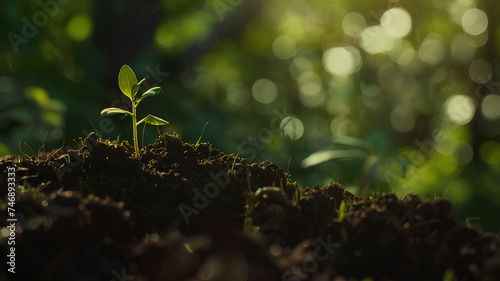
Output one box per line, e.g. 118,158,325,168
0,133,500,281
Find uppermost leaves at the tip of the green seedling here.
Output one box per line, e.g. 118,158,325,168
118,65,161,104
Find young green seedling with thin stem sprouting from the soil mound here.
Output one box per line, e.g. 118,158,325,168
101,65,168,158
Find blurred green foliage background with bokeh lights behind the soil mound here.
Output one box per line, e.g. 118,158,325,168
0,0,500,231
